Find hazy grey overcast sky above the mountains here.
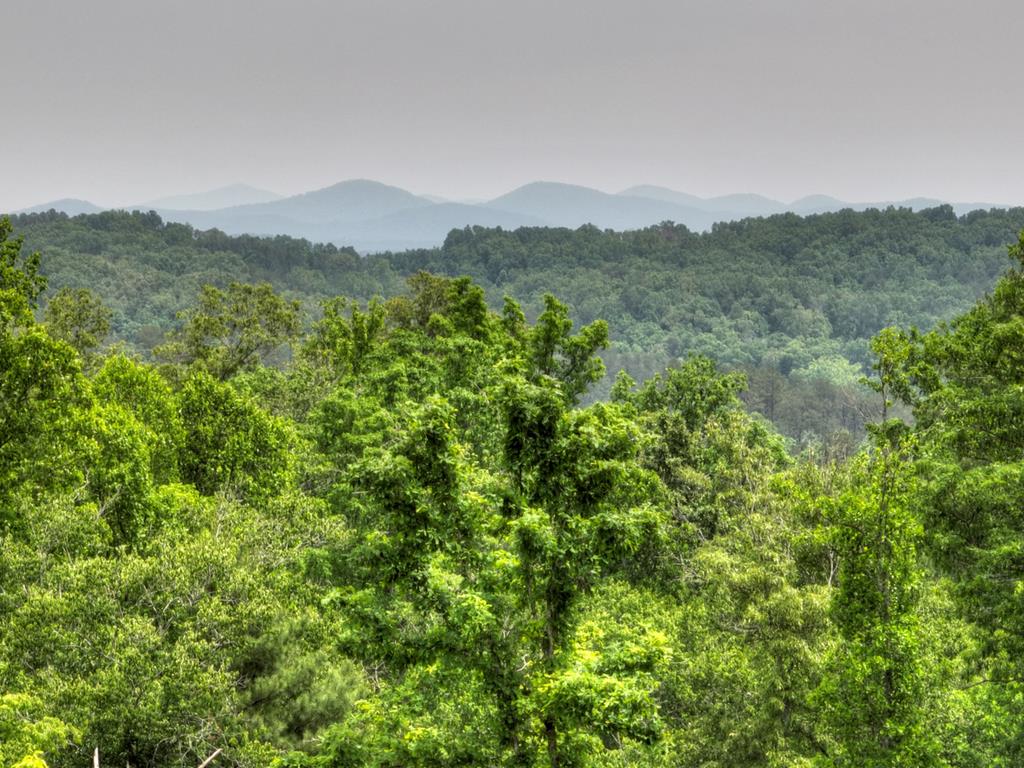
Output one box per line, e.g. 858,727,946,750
0,0,1024,210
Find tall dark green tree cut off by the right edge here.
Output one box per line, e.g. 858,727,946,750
876,228,1024,756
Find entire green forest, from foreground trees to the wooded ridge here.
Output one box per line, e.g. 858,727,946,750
0,208,1024,768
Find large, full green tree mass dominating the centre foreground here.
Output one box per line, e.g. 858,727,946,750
313,290,662,765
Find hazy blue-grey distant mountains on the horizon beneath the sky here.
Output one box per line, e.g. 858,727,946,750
12,179,1006,252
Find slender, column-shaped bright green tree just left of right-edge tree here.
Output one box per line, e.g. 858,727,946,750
816,442,937,768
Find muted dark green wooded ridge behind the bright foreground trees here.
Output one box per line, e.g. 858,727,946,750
14,206,1024,449
